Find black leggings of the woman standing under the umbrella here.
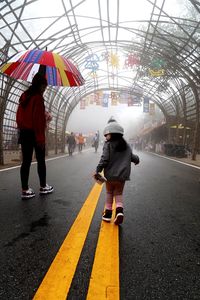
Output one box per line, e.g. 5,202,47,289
19,129,46,190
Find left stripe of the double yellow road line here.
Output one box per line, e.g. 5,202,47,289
33,183,103,300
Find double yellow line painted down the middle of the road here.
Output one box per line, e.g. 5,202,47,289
33,183,119,300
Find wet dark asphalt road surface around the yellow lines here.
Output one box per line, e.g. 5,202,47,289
0,150,200,300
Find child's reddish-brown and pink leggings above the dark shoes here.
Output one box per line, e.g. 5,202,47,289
105,181,125,210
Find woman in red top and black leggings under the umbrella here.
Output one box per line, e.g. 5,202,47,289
16,73,53,199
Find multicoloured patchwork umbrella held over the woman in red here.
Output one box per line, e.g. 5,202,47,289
0,50,84,87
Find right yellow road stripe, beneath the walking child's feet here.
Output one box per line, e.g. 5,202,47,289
87,204,120,300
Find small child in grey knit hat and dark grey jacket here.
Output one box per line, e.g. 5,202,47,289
94,118,139,225
